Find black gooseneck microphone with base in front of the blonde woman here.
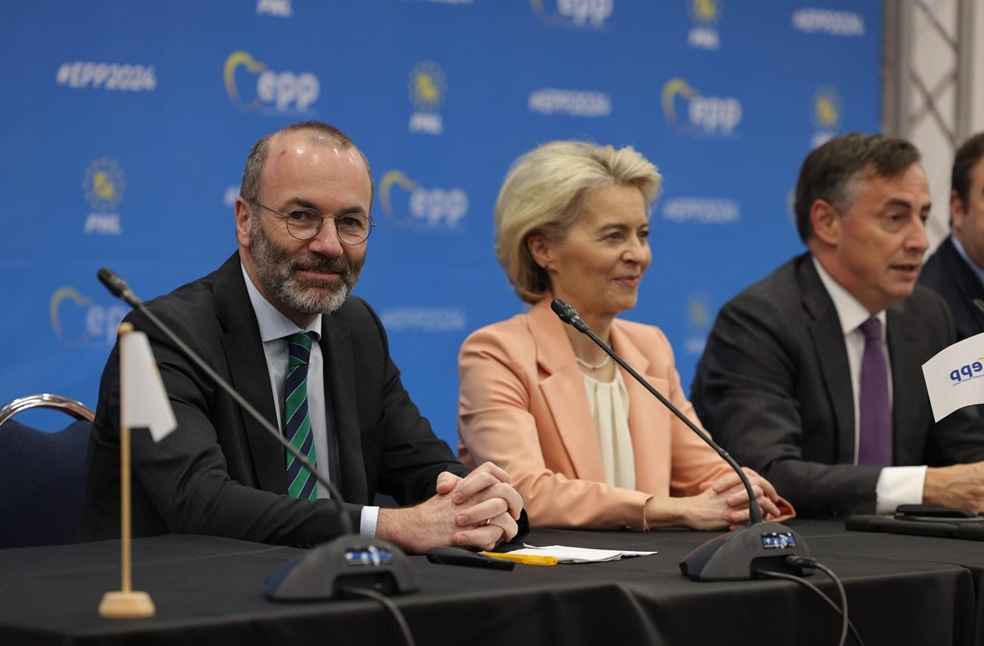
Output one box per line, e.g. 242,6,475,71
550,298,810,581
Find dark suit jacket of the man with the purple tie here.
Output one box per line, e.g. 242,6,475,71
691,254,984,516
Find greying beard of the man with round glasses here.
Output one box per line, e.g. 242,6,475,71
250,219,362,314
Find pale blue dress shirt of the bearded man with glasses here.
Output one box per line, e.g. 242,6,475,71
242,267,379,536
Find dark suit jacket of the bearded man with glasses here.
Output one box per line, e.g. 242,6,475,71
83,254,468,545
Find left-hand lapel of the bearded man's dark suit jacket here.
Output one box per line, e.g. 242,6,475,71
214,253,287,493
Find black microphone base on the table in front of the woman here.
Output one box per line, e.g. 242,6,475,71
680,522,810,581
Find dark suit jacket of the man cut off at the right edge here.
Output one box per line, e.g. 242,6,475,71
919,236,984,339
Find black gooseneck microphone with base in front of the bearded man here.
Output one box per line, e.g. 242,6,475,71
96,267,417,601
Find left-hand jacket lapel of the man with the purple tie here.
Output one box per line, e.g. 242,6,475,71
797,254,855,464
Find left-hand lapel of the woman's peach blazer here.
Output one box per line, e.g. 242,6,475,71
529,298,605,482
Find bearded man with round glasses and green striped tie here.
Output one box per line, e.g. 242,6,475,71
83,122,525,552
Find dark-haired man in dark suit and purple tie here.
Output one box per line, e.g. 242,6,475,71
691,134,984,516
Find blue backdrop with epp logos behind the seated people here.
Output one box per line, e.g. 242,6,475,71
0,0,882,445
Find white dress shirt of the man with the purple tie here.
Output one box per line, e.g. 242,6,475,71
813,258,926,514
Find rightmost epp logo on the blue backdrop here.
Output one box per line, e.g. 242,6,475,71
661,78,742,136
